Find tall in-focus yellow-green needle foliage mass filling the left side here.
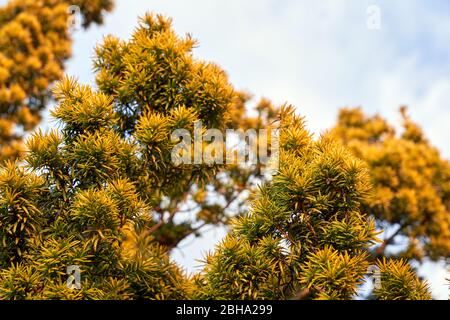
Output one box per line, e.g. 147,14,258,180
0,15,233,299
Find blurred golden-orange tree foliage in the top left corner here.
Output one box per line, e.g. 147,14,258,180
0,0,113,161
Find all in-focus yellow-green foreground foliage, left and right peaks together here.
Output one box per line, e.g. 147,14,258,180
0,10,436,299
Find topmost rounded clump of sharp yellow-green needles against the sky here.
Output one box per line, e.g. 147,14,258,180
94,15,233,133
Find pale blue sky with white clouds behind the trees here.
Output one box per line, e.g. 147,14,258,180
8,0,450,299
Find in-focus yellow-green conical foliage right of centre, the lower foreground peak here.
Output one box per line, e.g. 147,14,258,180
195,107,430,299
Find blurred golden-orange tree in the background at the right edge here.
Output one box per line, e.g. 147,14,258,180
333,108,450,260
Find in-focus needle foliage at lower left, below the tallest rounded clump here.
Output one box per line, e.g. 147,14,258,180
0,78,194,299
